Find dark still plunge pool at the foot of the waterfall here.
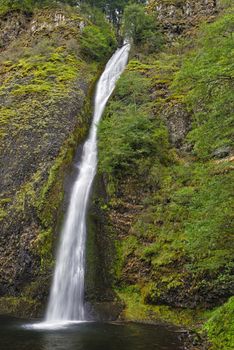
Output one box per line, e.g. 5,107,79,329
0,316,183,350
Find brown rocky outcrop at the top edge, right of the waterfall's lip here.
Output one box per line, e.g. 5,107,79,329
149,0,217,40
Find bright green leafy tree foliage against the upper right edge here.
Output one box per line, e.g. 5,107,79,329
176,13,234,159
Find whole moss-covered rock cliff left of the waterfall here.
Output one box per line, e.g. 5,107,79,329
0,1,116,316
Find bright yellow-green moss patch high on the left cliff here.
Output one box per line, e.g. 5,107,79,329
1,47,84,97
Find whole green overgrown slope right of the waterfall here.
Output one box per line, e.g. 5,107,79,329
96,2,234,350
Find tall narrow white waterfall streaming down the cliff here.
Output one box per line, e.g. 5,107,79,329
46,44,130,323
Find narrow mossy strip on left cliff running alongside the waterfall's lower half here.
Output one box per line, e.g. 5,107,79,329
28,109,91,271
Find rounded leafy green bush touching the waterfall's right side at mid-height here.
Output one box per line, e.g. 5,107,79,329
99,105,167,174
